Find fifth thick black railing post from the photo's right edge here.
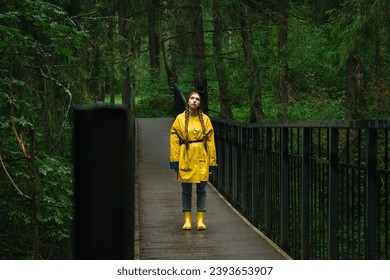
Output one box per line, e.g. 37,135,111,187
264,127,272,236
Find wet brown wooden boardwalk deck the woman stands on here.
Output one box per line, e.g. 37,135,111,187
135,119,289,260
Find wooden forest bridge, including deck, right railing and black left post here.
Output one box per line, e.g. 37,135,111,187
74,107,390,260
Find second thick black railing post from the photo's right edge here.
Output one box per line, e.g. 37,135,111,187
328,127,339,260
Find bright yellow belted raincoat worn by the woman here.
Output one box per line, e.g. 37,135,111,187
170,113,217,183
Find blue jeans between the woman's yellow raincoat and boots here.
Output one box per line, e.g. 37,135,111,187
181,182,207,212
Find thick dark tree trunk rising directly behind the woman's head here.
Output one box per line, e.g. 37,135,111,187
191,0,209,114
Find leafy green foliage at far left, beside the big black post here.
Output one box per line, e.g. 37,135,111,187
0,1,87,259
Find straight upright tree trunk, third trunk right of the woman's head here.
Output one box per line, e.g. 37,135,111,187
277,0,289,120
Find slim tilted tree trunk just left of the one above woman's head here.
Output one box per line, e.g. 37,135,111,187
161,0,178,88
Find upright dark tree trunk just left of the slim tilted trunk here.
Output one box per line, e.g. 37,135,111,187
148,0,160,83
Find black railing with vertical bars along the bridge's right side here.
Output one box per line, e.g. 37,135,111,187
211,120,390,259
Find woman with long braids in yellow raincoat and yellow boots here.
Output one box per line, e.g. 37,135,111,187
170,91,217,230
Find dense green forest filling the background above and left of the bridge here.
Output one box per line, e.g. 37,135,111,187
0,0,390,259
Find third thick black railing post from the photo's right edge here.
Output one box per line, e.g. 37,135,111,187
301,127,311,260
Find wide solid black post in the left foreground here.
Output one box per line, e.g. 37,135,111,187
73,106,135,259
